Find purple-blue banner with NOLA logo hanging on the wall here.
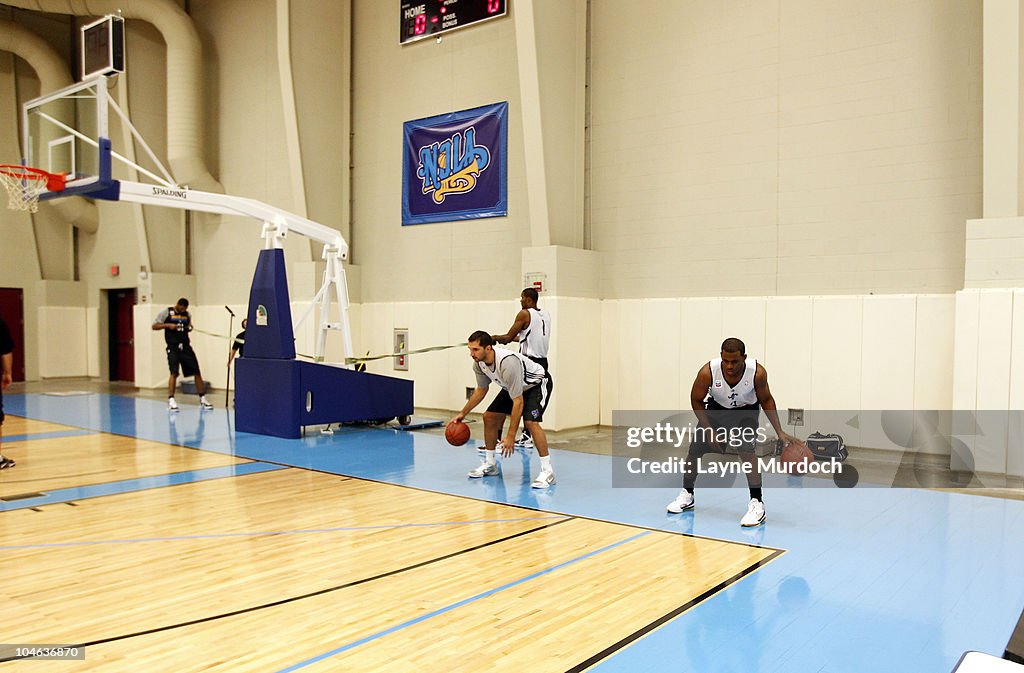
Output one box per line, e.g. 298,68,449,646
401,102,509,225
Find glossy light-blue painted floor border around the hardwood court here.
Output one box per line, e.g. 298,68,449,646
6,393,1024,673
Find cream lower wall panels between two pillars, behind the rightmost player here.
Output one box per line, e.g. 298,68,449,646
601,295,954,423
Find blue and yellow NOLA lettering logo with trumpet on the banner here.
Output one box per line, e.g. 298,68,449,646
416,126,490,204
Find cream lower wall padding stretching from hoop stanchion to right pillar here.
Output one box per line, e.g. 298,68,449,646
344,295,958,428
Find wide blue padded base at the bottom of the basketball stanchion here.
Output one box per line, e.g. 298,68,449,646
234,356,413,438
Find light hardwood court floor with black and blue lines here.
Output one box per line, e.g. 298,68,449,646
0,417,781,671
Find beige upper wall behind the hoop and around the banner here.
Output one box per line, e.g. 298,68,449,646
0,0,981,303
